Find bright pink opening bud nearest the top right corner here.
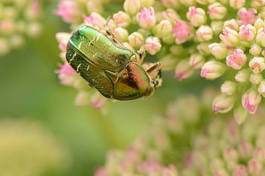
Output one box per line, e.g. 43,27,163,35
238,8,257,25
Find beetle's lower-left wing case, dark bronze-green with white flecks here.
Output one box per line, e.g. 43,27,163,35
66,44,113,98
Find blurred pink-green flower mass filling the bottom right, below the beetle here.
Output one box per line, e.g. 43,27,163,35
95,95,265,176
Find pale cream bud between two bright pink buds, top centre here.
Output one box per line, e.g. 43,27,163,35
154,20,173,37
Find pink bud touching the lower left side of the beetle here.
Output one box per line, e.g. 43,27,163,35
57,63,75,85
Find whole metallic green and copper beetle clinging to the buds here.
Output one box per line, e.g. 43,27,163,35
66,25,161,100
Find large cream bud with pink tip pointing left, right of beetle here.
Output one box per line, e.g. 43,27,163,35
201,60,225,80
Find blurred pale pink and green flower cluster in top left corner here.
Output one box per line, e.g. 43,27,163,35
0,0,41,55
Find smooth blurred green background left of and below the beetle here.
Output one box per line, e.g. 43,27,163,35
0,2,208,176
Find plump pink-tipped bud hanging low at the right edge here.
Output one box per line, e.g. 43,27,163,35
242,89,261,114
